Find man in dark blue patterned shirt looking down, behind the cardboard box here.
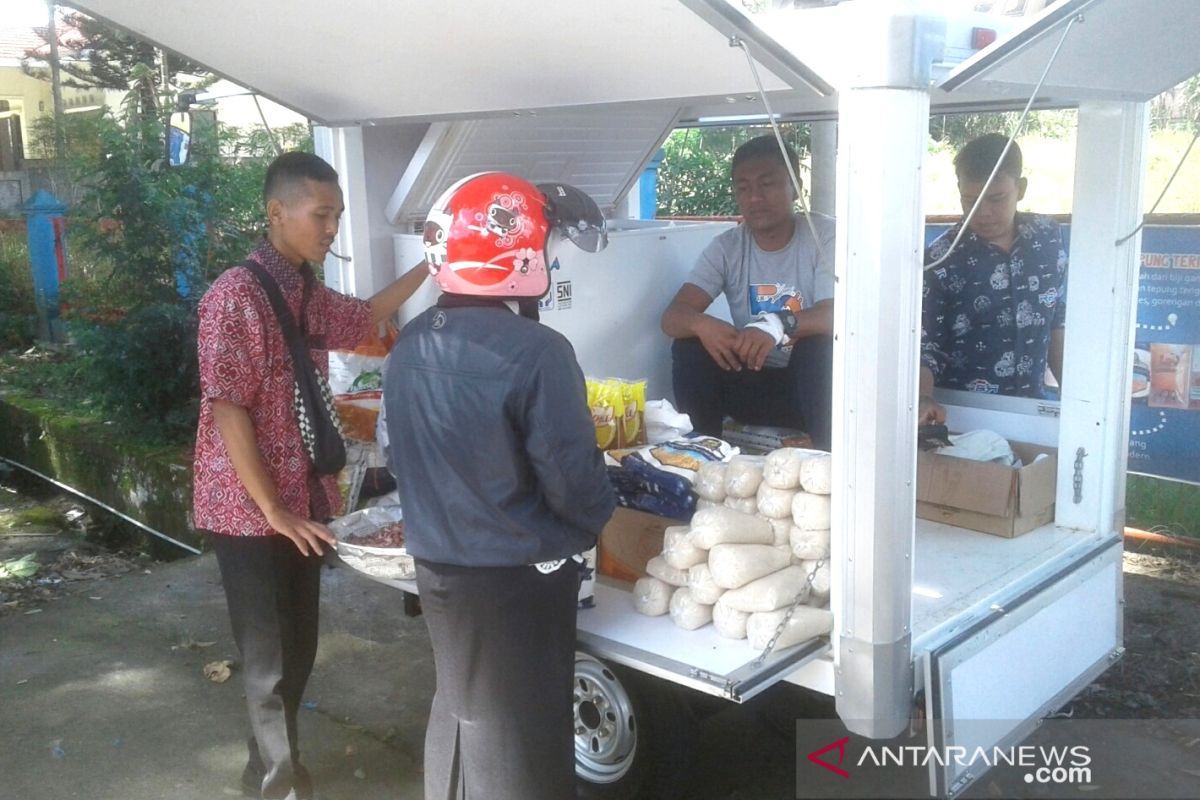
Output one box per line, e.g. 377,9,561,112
919,133,1067,422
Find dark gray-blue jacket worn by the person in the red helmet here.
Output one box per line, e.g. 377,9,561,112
384,297,616,566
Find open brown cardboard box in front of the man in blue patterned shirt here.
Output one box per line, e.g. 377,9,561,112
917,441,1058,539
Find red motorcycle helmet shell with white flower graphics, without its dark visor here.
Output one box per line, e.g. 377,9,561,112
424,173,550,297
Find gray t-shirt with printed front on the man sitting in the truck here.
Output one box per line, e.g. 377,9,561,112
688,213,834,367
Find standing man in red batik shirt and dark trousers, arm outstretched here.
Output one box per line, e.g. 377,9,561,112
194,152,428,800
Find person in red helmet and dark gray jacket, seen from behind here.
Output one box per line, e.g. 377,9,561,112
384,173,616,800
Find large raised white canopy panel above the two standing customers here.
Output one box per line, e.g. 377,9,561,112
73,0,830,125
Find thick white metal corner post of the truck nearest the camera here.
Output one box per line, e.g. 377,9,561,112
833,79,929,738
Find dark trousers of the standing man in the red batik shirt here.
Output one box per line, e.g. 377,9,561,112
211,535,322,800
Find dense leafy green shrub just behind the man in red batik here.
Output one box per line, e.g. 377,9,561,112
56,106,311,441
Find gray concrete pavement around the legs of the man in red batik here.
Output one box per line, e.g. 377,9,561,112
0,555,433,800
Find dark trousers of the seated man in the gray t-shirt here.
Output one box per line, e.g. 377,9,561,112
671,336,833,450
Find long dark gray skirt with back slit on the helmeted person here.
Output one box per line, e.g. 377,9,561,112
416,560,580,800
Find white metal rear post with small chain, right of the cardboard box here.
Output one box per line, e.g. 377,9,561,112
1056,102,1148,537
